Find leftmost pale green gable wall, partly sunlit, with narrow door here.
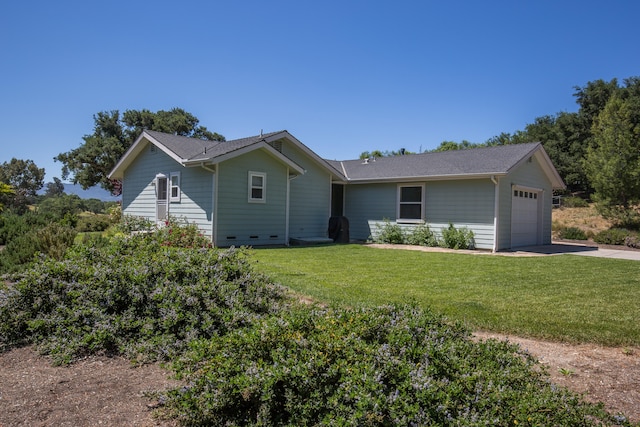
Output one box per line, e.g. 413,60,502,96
122,144,213,237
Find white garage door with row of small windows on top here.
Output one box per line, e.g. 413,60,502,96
511,188,541,247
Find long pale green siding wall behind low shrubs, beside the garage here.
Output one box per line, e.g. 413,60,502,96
345,179,495,249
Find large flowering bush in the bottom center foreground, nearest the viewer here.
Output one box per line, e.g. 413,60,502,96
160,306,628,426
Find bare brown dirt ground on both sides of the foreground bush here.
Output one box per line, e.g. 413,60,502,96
0,332,640,427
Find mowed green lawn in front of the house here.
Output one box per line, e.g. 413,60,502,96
253,245,640,346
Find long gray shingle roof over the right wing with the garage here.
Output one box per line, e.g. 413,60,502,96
329,143,541,181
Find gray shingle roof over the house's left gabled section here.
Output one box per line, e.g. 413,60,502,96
145,130,279,161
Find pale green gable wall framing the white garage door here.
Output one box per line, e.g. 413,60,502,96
498,155,553,250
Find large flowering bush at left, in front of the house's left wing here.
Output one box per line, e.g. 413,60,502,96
0,226,287,363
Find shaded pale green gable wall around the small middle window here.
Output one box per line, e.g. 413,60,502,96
215,150,288,246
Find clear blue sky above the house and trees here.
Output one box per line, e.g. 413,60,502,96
0,0,640,181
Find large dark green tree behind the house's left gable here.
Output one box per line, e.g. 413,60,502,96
54,108,225,194
